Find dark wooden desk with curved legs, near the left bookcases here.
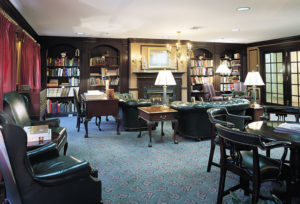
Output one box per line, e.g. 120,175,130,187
81,94,120,138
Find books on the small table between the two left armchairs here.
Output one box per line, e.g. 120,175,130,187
24,125,51,142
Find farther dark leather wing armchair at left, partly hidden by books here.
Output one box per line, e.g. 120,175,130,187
4,92,68,155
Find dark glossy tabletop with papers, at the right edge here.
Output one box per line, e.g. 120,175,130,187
245,121,300,146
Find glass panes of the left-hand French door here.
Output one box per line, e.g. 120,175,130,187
265,52,284,105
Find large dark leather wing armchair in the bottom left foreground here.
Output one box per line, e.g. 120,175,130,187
0,125,101,204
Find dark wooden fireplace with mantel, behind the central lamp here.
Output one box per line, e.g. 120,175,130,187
134,72,184,103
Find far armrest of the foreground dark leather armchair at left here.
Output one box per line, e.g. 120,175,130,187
27,142,59,164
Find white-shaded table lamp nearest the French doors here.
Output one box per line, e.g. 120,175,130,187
244,71,265,108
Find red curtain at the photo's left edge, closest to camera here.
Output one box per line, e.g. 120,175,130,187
0,14,17,110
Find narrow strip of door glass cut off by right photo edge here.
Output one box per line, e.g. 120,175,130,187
290,51,300,107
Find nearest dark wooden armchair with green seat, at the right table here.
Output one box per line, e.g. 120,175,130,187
216,124,290,204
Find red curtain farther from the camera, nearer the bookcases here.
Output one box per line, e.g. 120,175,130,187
20,35,41,89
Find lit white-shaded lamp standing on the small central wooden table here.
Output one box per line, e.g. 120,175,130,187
154,70,176,106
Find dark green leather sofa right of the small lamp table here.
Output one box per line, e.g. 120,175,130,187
171,99,250,141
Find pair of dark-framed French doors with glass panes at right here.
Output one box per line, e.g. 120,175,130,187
263,50,300,107
